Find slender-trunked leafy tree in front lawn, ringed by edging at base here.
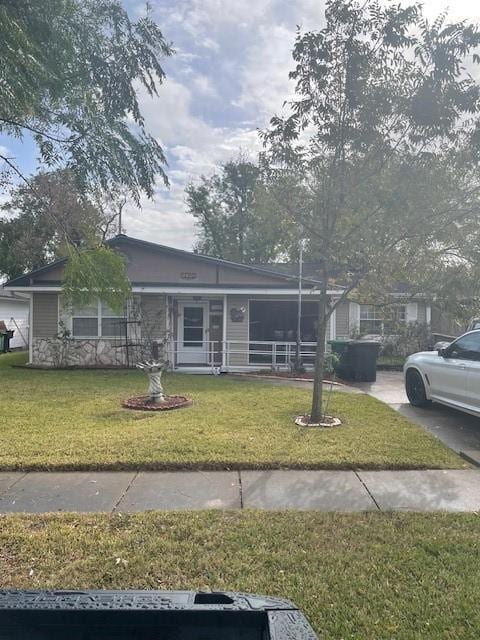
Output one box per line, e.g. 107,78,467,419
263,0,480,420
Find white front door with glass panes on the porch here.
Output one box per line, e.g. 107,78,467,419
177,302,208,365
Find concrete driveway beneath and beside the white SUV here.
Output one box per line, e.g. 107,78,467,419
351,371,480,465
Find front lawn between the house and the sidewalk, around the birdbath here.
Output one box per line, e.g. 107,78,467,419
0,354,468,470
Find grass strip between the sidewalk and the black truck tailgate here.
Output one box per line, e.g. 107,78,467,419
0,511,480,640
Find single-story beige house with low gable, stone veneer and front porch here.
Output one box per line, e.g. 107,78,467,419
2,234,430,371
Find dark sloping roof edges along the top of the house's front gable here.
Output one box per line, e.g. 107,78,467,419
6,234,342,291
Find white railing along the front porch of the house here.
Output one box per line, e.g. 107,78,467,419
169,340,316,370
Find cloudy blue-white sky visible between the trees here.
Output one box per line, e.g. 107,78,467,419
0,0,480,249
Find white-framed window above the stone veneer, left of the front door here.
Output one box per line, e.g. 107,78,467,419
72,302,125,338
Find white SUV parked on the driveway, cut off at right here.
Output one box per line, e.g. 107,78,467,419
403,329,480,417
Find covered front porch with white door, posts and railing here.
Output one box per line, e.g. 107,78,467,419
167,295,335,373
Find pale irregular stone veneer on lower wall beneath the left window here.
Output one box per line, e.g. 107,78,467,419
32,338,125,367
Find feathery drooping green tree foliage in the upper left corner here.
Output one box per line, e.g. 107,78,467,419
0,0,172,202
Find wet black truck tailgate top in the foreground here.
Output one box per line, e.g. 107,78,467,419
0,590,317,640
